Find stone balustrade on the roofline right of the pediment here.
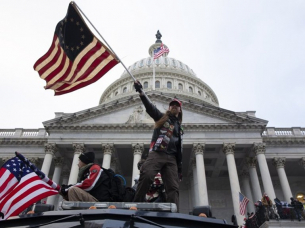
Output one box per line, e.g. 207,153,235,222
262,127,305,137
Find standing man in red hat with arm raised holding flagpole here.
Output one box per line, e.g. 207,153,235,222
134,81,183,209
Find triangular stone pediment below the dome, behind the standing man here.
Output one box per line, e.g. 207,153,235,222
43,91,267,129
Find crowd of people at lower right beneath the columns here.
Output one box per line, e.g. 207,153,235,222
242,193,305,228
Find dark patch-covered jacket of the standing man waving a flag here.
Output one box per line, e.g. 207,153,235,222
140,96,183,173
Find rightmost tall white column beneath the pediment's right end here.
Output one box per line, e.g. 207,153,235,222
253,143,275,201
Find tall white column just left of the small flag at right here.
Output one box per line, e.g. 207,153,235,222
223,143,244,225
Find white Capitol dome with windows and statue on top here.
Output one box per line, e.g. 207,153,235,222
99,33,219,107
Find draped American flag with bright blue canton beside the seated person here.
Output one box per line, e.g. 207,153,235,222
0,152,60,221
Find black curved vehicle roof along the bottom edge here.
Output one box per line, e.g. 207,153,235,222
0,209,237,228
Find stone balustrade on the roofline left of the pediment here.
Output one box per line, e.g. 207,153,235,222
0,128,48,138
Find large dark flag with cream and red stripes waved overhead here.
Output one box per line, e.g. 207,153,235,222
34,2,119,95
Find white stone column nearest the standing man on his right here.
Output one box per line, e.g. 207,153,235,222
193,143,209,206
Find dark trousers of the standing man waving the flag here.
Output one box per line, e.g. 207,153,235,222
134,151,179,209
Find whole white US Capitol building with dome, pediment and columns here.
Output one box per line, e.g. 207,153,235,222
0,32,305,224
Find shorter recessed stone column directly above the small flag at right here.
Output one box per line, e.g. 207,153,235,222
246,157,262,203
